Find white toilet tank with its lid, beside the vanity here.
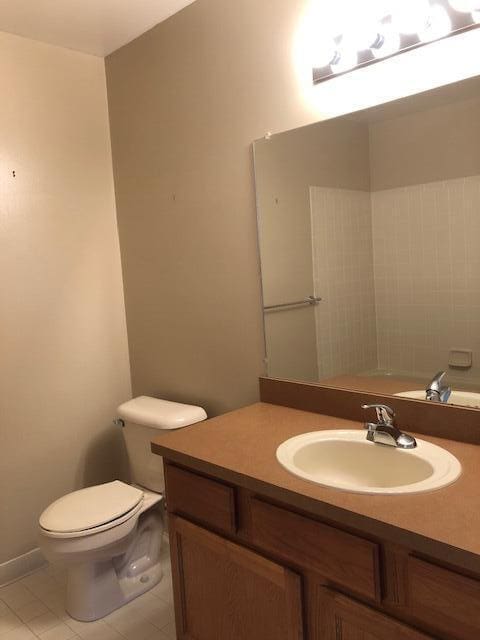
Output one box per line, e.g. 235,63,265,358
117,396,207,493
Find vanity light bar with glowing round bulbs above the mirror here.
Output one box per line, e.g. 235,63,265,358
311,0,480,84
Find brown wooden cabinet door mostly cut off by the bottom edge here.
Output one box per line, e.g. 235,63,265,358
317,590,433,640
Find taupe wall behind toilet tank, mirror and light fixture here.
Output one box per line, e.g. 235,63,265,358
106,0,480,413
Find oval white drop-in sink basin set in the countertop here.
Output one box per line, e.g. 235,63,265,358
277,430,462,494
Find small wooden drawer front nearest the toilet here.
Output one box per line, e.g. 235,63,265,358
165,464,237,533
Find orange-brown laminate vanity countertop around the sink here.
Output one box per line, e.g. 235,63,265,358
152,402,480,573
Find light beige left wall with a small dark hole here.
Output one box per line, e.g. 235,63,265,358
0,34,130,563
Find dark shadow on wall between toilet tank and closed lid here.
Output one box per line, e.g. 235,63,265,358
76,426,130,487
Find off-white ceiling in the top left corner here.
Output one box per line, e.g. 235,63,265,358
0,0,194,56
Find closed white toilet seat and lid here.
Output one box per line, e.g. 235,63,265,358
39,480,144,538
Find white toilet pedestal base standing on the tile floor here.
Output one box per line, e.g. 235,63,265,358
65,510,163,622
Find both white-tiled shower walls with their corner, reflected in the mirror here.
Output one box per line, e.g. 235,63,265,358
310,176,480,383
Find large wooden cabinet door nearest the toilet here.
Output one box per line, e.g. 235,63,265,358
169,516,303,640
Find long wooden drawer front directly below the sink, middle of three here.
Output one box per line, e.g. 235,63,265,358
251,499,380,600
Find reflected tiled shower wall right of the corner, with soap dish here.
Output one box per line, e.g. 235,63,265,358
372,176,480,382
